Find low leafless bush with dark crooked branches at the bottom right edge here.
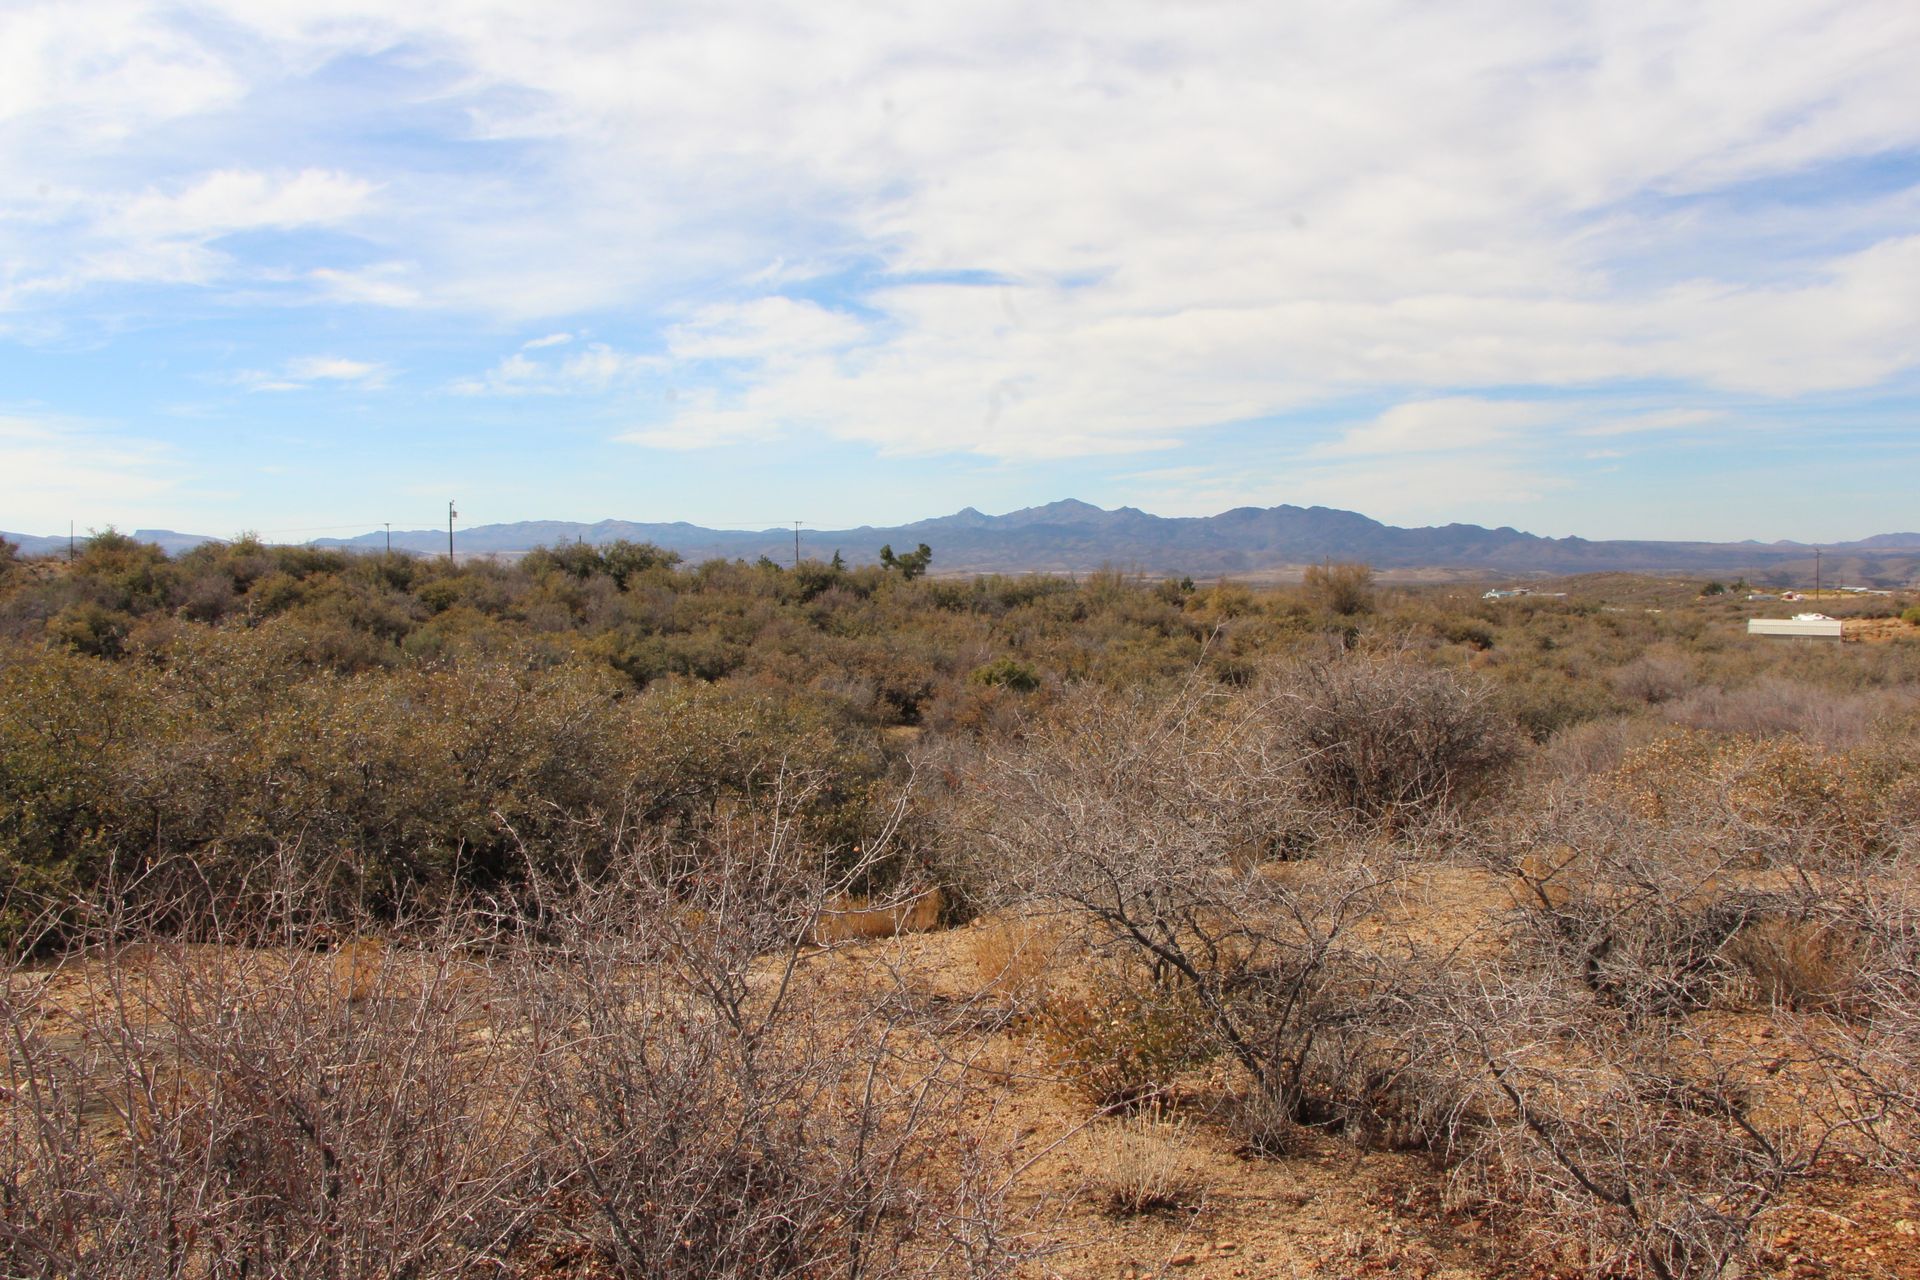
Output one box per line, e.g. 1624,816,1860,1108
1427,975,1834,1280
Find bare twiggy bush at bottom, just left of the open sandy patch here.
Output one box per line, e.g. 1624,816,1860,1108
499,782,1036,1276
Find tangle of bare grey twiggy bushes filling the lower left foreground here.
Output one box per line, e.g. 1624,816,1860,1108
0,771,1020,1280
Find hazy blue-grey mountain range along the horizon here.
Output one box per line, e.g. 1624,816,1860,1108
0,499,1920,585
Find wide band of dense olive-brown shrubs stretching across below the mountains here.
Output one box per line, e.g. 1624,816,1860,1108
0,533,1920,946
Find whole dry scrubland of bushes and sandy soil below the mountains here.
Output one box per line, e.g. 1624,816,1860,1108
0,535,1920,1280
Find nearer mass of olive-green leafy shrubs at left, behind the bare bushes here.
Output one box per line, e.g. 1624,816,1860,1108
0,637,893,944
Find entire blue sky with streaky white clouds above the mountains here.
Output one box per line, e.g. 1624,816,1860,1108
0,0,1920,539
